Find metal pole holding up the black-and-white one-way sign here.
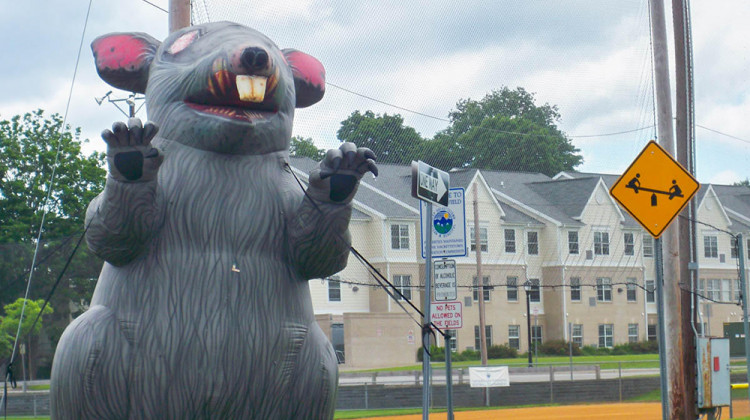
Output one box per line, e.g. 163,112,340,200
422,201,432,420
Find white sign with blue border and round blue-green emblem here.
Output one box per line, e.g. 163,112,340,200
419,188,467,258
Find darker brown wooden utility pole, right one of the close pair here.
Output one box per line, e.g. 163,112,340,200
672,0,698,419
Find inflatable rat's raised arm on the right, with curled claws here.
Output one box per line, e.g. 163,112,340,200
289,143,378,279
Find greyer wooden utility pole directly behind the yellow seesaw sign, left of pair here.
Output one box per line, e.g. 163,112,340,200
649,0,686,420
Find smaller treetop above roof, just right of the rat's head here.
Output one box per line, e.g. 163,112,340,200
336,111,424,164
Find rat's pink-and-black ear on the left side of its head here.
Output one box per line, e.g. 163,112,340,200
91,32,161,93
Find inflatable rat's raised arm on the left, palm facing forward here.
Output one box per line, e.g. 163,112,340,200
86,118,164,266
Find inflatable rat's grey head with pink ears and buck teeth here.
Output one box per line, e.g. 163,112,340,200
91,22,325,154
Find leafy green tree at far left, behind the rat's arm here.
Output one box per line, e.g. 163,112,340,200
0,110,106,378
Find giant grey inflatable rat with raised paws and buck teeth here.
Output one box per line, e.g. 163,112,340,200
51,22,377,419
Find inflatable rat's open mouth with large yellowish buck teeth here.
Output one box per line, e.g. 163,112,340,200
185,59,279,122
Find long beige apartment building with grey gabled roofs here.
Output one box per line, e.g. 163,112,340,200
291,158,750,367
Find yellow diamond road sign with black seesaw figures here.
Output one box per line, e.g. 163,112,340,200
609,140,700,238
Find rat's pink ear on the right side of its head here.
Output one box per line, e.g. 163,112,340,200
282,49,326,108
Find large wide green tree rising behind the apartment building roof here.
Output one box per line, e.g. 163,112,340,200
420,87,583,176
